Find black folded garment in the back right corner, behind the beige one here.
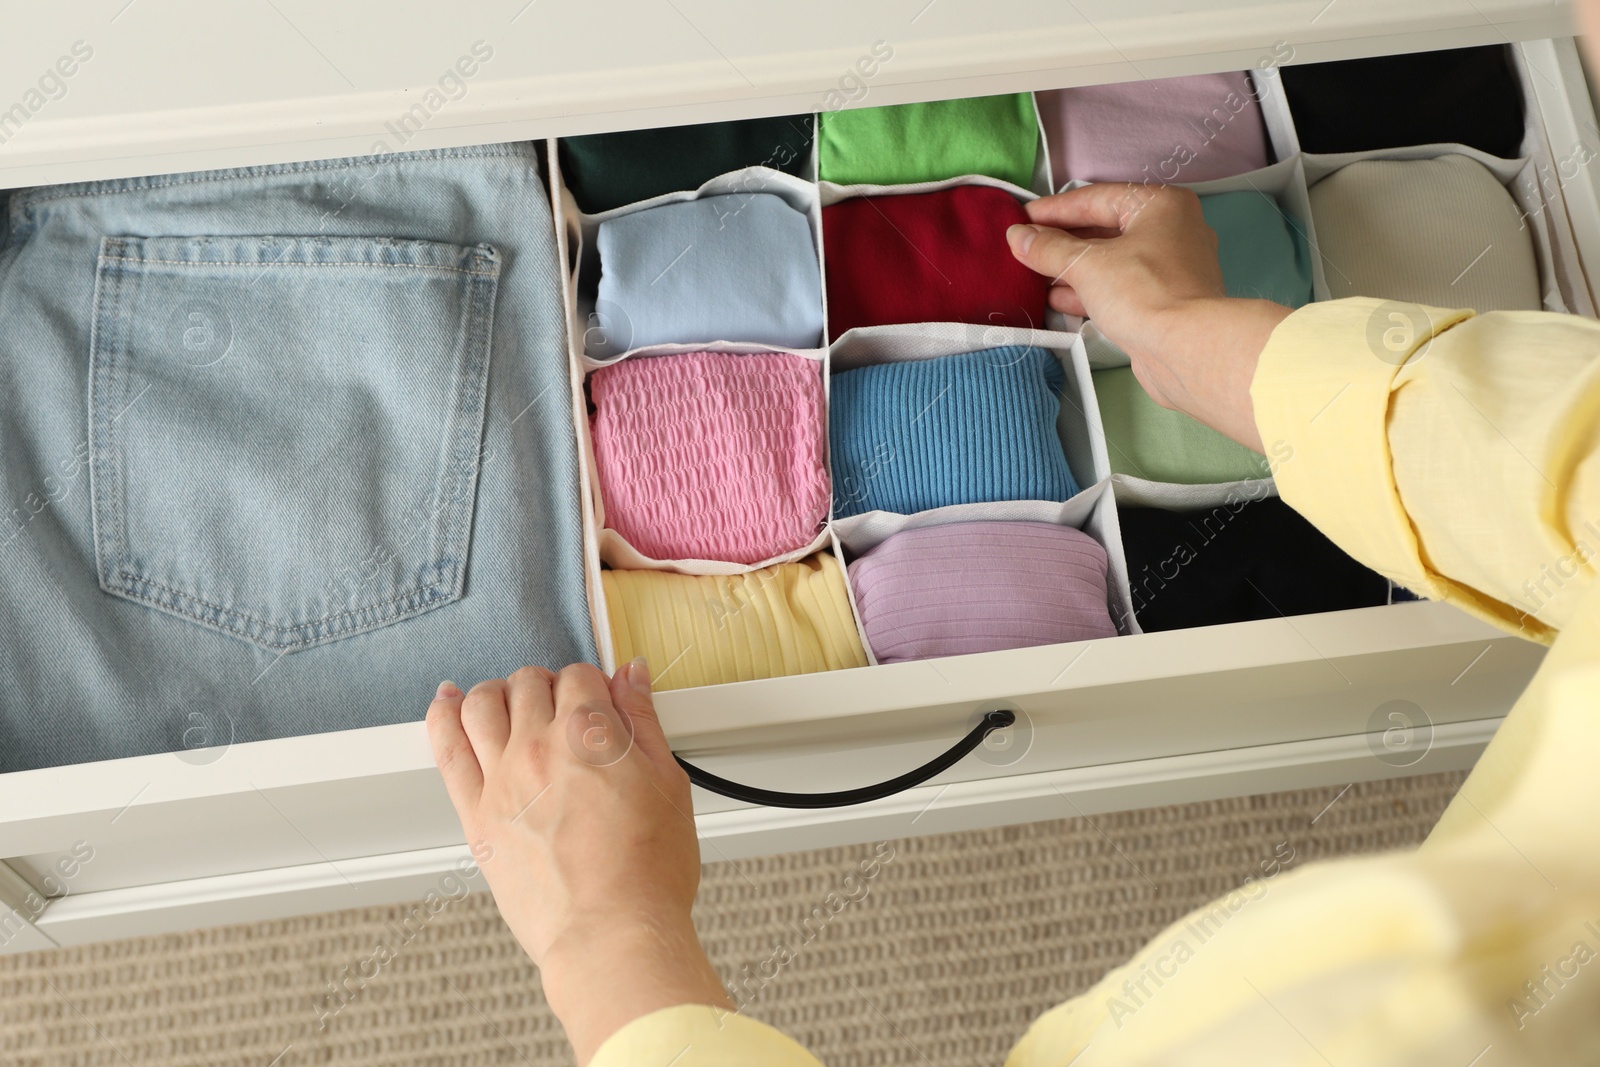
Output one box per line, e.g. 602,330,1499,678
1280,45,1523,160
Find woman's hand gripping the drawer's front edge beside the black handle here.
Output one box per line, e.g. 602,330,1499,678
427,659,731,1064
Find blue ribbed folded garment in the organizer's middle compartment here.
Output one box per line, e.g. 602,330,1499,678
829,346,1078,518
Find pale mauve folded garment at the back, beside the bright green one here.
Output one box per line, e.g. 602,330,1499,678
1037,72,1270,189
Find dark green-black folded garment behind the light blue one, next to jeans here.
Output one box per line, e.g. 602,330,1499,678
557,115,816,214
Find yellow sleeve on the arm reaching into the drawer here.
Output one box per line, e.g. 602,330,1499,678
1251,298,1600,643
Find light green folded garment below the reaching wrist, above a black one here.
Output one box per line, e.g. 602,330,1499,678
1094,366,1272,485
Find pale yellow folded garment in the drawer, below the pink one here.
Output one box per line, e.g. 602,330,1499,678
600,552,867,689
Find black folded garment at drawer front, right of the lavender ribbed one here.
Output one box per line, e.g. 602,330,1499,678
1117,498,1389,632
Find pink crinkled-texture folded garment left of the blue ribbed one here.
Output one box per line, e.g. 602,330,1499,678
589,352,829,563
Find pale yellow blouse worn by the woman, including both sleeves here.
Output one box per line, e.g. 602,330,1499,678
592,298,1600,1067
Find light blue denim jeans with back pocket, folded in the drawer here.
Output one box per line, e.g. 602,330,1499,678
0,144,597,771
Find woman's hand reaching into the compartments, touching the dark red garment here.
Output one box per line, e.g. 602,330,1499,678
1006,184,1290,451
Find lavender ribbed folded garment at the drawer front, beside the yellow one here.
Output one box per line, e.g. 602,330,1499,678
850,522,1117,664
